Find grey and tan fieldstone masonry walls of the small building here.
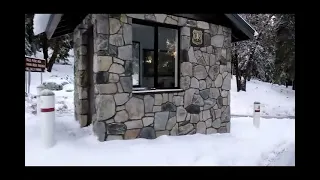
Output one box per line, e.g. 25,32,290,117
74,14,231,141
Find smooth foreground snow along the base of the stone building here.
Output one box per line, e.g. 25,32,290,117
25,116,295,166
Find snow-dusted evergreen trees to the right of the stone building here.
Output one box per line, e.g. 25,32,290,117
232,14,295,91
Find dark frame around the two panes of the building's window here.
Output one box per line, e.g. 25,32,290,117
132,18,181,89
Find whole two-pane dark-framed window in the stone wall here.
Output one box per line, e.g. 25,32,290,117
132,19,179,89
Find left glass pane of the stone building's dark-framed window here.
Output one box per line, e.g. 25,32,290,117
132,24,154,88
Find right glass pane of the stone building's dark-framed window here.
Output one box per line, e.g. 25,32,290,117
157,27,178,88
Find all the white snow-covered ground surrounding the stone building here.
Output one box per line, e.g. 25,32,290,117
25,50,295,166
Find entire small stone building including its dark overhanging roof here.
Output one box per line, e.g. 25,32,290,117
42,14,255,141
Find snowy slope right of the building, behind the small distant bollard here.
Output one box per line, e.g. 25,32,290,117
230,76,295,117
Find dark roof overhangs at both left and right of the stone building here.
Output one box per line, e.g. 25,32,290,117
40,14,257,42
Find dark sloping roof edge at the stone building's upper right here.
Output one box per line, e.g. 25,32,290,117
225,14,257,39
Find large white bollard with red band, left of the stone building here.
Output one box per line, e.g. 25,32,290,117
40,89,56,148
